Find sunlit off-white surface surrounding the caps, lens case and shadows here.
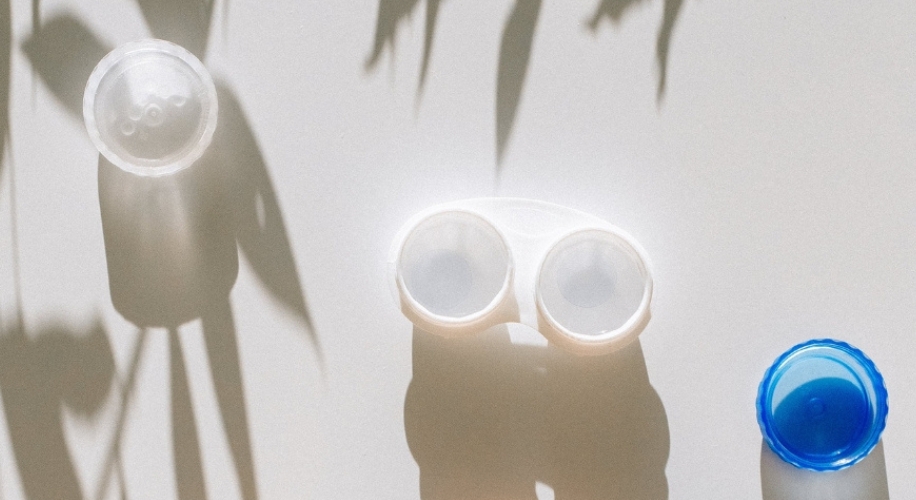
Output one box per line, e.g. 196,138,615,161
0,0,916,500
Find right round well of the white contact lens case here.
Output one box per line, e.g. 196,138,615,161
537,230,647,337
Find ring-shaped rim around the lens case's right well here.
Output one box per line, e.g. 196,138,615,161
534,227,653,352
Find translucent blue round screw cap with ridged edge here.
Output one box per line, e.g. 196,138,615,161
757,339,888,471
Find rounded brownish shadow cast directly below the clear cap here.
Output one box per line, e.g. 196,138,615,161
98,133,238,327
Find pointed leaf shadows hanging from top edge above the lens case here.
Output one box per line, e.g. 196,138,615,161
366,0,684,176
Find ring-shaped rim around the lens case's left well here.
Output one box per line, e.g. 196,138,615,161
395,208,515,327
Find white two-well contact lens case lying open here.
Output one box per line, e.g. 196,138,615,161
388,198,652,355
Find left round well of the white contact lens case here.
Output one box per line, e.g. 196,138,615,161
398,211,511,323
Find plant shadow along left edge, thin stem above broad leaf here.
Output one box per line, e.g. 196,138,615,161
0,0,108,500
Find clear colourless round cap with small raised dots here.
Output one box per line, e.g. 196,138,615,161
83,40,217,176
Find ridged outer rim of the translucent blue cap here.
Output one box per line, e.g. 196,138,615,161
756,339,888,471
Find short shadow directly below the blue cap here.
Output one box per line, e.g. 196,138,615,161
760,440,890,500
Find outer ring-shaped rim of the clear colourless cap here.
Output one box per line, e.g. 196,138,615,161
83,38,219,177
